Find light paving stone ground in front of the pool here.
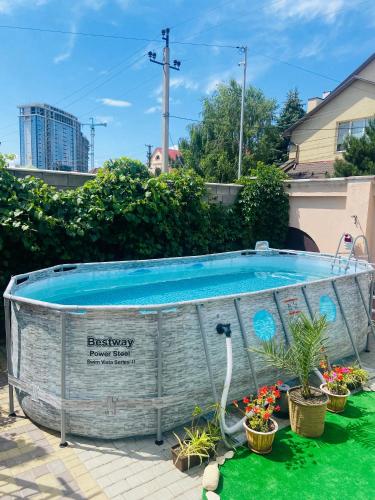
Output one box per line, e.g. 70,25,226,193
0,342,375,500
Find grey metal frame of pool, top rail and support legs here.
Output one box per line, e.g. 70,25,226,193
4,249,375,447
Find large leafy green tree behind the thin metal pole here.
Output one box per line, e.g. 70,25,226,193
179,80,277,182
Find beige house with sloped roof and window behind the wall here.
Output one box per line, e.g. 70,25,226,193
284,53,375,178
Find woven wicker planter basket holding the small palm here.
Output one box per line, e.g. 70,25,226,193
288,386,328,437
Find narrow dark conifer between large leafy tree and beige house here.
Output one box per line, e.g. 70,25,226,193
271,88,305,163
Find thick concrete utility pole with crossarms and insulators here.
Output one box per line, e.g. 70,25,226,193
148,28,181,172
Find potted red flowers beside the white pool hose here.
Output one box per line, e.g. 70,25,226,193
233,386,280,455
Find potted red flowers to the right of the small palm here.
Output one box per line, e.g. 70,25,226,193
320,365,351,413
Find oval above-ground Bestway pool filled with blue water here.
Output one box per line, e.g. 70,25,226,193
4,250,373,440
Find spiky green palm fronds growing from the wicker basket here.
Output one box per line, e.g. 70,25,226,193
251,314,327,399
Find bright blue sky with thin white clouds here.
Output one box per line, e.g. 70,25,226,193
0,0,375,166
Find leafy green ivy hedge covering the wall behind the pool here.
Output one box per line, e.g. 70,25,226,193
0,158,288,336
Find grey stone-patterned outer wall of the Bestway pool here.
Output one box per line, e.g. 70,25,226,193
11,274,370,438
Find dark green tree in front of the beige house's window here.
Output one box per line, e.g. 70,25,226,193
334,120,375,177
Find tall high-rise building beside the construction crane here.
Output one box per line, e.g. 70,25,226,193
18,103,89,172
